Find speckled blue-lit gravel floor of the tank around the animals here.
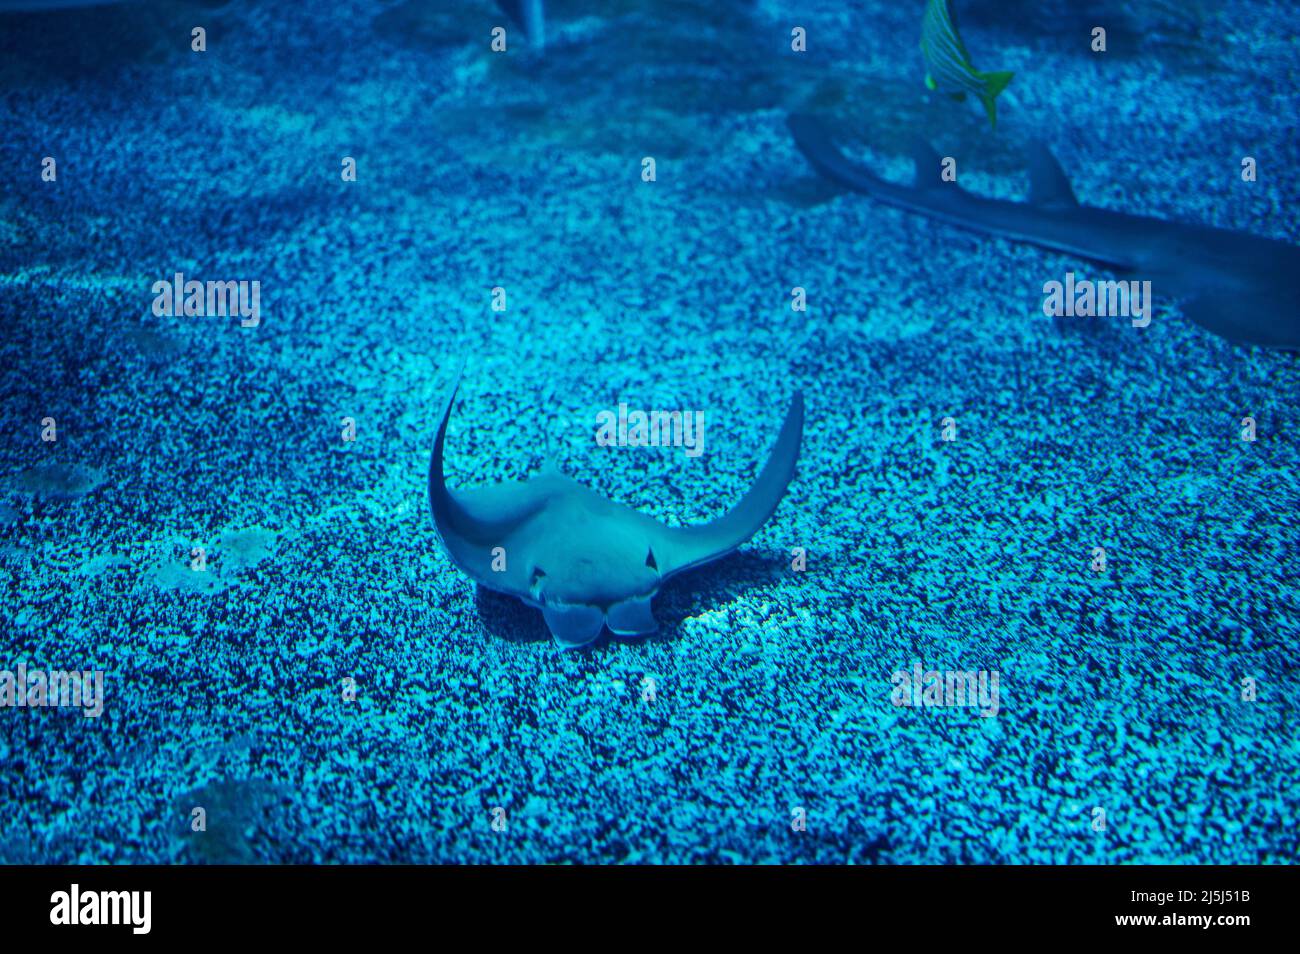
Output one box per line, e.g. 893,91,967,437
0,0,1300,863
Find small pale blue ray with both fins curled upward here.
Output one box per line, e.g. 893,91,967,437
429,381,803,649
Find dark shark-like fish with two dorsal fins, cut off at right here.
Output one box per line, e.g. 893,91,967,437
787,116,1300,351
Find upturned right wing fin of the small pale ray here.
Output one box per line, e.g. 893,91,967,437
663,391,803,576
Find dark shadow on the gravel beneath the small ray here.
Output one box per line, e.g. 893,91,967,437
475,551,790,651
